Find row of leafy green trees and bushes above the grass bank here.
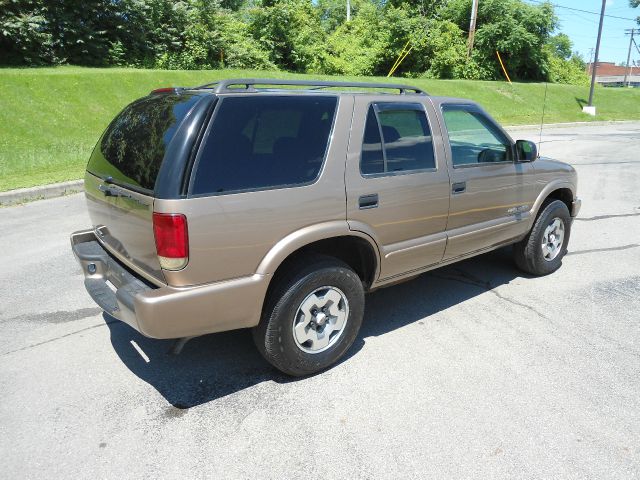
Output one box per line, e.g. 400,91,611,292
0,0,580,82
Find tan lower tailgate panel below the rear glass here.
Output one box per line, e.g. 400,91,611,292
84,172,166,285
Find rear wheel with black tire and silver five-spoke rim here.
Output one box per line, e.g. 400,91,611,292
253,256,364,376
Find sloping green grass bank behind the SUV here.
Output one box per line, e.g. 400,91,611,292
0,67,640,191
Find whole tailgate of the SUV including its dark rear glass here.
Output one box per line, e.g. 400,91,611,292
80,93,202,285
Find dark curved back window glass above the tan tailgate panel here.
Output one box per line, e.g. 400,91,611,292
87,95,200,191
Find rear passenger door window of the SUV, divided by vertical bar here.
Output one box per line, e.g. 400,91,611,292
360,103,435,175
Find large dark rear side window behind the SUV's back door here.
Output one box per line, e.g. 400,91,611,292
192,95,337,194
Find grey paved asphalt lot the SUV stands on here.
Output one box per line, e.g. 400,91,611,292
0,123,640,480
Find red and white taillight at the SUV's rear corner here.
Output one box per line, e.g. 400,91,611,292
153,213,189,270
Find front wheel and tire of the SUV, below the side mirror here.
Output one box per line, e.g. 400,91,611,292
513,200,571,275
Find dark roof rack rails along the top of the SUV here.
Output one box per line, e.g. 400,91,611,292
194,78,428,95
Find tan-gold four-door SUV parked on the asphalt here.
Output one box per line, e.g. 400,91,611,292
71,79,580,375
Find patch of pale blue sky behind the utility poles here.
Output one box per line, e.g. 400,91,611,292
525,0,640,64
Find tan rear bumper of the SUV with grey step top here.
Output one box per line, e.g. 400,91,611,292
71,230,269,338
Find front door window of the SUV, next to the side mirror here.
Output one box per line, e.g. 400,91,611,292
443,107,511,166
